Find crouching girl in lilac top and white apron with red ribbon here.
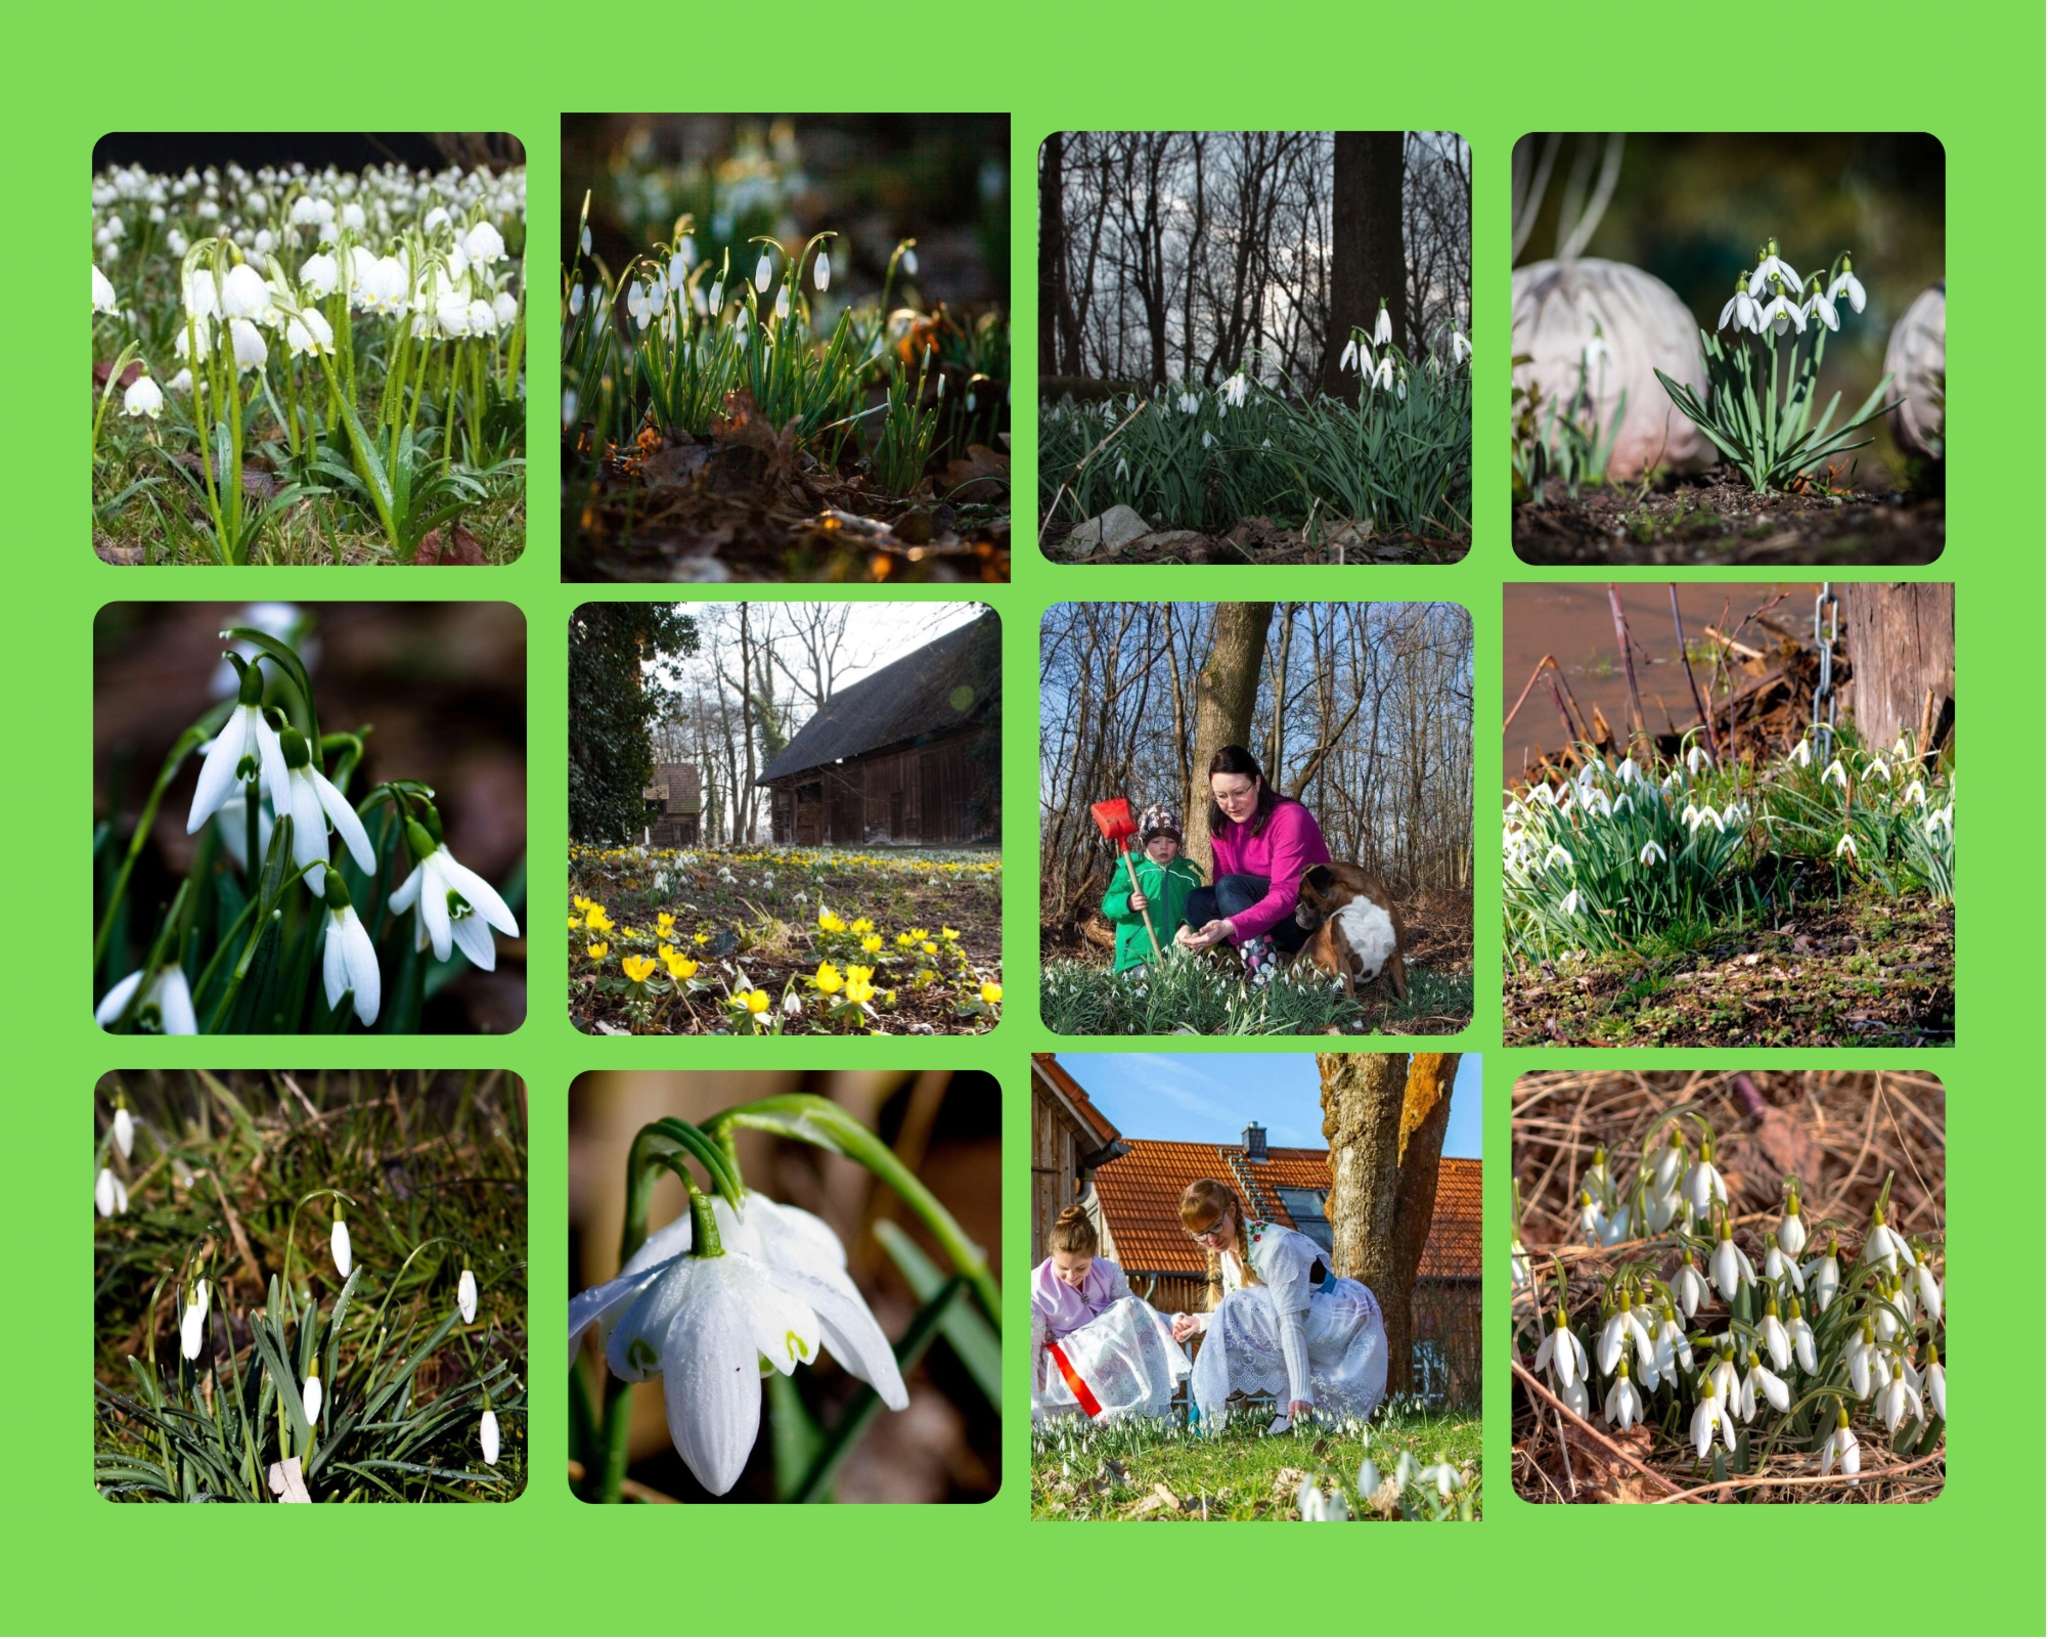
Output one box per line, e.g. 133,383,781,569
1030,1207,1188,1420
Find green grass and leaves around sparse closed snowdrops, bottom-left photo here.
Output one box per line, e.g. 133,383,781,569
92,1071,526,1502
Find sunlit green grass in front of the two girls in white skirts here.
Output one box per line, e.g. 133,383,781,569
1030,1405,1483,1520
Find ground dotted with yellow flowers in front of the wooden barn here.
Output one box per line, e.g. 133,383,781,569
567,846,1001,1035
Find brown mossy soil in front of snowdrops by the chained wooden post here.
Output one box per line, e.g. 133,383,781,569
1501,899,1956,1047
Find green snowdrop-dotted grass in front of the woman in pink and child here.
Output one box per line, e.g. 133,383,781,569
1038,955,1473,1037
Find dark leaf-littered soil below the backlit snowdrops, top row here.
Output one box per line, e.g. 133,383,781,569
561,404,1010,584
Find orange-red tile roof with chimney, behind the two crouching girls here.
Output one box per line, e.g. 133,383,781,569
1094,1139,1485,1280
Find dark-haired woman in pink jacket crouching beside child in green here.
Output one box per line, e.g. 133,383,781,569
1176,746,1329,983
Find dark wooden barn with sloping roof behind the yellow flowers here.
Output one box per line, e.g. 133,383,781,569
758,611,1001,848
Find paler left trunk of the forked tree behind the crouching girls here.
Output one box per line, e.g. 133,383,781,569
1315,1053,1407,1309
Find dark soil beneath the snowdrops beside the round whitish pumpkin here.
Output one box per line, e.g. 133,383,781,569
1513,473,1946,565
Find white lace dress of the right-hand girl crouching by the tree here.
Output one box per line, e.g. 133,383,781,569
1188,1221,1386,1422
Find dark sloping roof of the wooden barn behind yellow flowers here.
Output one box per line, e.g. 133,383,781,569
756,611,1001,785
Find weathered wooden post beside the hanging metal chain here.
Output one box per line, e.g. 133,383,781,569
1837,582,1956,756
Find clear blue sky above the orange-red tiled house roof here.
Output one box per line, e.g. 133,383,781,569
1059,1053,1481,1155
